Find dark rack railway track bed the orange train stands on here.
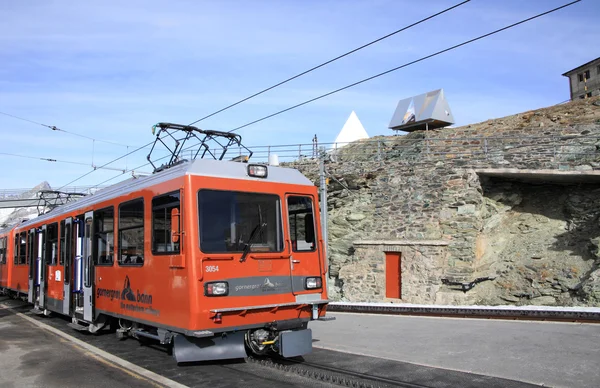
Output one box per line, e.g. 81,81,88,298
0,297,552,388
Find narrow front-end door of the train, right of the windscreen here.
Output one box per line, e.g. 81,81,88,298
286,194,323,294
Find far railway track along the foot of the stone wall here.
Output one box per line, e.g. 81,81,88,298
327,302,600,323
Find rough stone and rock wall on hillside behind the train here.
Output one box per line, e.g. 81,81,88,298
292,99,600,304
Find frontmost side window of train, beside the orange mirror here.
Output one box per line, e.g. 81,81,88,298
152,191,180,254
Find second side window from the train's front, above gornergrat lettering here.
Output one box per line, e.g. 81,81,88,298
118,198,144,266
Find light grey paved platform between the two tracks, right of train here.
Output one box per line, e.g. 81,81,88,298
311,313,600,387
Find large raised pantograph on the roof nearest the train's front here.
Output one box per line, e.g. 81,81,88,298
147,123,252,173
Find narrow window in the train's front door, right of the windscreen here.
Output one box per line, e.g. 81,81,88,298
287,196,316,252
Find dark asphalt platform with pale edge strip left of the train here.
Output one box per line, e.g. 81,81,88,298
0,298,184,388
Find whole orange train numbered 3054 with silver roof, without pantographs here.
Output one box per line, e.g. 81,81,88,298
0,159,328,362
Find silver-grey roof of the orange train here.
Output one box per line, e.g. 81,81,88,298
12,159,314,233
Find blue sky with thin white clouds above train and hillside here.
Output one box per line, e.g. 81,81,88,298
0,0,600,189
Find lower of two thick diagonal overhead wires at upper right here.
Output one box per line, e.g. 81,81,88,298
229,0,581,132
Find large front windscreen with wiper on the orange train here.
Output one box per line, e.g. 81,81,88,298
198,190,283,253
